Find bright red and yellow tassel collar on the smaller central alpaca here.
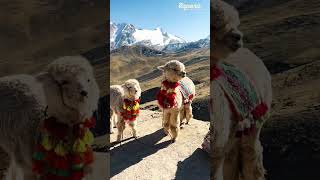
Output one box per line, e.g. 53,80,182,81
121,99,140,121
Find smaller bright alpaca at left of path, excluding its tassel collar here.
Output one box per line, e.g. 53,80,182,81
110,79,141,141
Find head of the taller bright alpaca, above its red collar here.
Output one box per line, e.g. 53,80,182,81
158,60,186,82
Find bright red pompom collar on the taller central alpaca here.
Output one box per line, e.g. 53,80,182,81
157,81,180,109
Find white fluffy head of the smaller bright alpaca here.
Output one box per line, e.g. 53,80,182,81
123,79,141,99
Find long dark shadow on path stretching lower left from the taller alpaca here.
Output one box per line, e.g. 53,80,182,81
110,129,171,177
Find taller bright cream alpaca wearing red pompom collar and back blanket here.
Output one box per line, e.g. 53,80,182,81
157,60,195,142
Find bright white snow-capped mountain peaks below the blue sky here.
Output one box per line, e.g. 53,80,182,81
110,22,186,50
